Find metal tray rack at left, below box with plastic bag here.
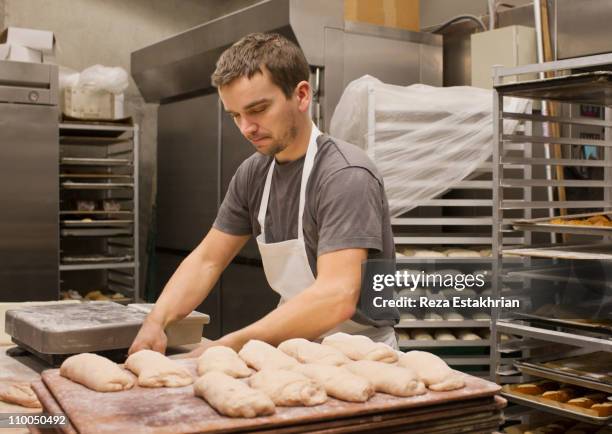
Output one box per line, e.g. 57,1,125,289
59,121,141,301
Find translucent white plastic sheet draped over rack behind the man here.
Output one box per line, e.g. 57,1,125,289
330,75,528,217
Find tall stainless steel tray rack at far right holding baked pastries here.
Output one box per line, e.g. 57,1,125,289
491,54,612,423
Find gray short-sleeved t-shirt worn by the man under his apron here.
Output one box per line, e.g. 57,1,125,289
213,135,395,327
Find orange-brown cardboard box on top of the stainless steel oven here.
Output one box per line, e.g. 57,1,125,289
344,0,420,32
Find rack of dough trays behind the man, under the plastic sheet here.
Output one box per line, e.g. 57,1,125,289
367,83,524,377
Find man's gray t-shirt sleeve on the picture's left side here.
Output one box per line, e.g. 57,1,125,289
213,160,253,235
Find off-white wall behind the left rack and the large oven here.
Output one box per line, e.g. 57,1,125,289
0,0,256,291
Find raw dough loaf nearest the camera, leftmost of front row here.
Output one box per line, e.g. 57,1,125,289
193,371,276,417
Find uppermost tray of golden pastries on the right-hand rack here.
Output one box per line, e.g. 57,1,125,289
513,211,612,235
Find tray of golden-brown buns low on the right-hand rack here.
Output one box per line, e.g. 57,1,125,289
502,380,612,424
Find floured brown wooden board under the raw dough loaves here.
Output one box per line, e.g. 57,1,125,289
37,360,501,434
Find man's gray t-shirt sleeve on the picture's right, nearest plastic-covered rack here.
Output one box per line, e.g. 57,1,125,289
316,167,383,256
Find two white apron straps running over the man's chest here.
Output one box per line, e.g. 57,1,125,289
257,123,321,241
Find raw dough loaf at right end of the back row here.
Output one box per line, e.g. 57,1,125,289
322,332,397,363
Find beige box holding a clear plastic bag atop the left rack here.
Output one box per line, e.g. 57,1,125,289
62,87,124,120
